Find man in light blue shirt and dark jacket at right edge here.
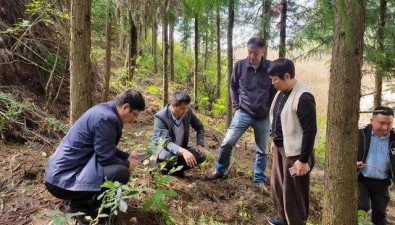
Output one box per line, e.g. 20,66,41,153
357,106,395,225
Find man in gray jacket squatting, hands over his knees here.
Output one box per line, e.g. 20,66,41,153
152,90,206,177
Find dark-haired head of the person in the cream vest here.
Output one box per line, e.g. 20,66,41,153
268,58,295,91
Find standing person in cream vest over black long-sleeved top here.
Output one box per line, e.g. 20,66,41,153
268,58,317,225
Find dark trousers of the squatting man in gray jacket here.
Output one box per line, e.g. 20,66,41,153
158,147,206,172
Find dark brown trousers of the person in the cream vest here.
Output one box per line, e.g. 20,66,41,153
271,147,314,225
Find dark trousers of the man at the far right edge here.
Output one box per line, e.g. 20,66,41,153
358,174,390,225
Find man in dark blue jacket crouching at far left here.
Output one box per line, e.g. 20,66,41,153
45,89,145,223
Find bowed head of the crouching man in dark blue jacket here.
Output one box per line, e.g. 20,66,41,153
114,88,145,124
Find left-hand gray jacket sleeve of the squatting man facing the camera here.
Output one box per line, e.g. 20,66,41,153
151,116,180,155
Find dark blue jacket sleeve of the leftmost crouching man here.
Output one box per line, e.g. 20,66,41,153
94,118,129,167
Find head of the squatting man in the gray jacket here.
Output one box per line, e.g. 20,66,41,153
170,90,191,118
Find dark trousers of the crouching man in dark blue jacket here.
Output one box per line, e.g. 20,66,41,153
45,165,129,218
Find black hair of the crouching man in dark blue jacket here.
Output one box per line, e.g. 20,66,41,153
114,88,145,111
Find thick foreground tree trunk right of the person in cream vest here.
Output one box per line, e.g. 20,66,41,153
322,0,366,225
